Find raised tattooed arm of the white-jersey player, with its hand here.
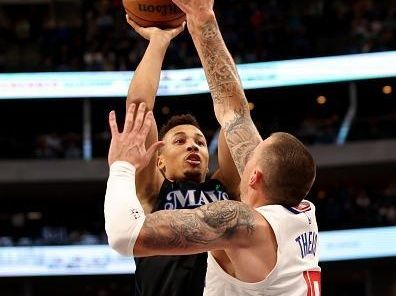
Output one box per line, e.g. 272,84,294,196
173,0,262,175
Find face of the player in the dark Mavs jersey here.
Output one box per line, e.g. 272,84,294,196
158,124,209,182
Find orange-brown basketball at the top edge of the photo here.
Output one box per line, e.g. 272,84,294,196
122,0,186,29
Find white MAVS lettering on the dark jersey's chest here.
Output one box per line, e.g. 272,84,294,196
164,189,229,210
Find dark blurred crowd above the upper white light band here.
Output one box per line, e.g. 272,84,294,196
0,0,396,72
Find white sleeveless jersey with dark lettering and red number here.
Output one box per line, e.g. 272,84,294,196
204,200,320,296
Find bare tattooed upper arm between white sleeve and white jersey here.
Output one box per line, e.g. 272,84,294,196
133,201,263,257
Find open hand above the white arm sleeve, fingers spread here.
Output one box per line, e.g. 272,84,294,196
108,103,164,171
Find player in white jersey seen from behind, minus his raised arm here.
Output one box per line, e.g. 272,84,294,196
105,104,320,296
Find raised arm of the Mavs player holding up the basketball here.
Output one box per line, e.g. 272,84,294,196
126,16,184,212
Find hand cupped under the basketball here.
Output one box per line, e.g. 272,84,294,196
125,14,186,42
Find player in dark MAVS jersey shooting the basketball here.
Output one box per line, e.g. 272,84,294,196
126,17,240,296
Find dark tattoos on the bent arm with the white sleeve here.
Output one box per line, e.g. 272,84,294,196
141,201,254,250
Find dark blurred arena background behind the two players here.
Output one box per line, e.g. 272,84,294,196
0,0,396,296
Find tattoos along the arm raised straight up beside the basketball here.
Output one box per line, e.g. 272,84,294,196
193,20,261,175
